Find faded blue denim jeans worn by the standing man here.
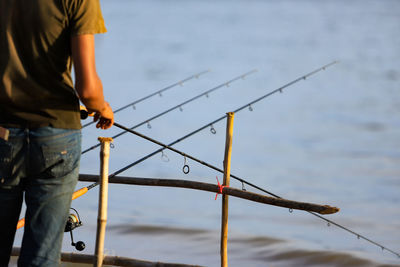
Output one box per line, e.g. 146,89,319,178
0,127,81,267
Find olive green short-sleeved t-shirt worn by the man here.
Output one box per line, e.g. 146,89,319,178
0,0,106,129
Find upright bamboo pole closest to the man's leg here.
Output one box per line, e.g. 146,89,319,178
93,137,113,267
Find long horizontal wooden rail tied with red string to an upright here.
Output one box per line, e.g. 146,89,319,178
79,174,339,214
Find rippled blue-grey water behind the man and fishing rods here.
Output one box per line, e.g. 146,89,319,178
10,0,400,266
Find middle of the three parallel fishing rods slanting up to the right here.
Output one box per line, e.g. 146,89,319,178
82,70,257,155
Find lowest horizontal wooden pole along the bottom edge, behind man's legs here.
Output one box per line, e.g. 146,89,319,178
11,247,202,267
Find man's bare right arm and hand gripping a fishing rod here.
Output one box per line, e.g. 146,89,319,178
71,34,114,129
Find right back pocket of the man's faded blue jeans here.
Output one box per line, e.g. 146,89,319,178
41,138,80,178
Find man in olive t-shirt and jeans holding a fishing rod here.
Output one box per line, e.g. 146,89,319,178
0,0,114,267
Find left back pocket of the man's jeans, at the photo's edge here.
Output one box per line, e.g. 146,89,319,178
0,140,13,187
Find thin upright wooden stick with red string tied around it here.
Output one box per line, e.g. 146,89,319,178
220,112,235,267
